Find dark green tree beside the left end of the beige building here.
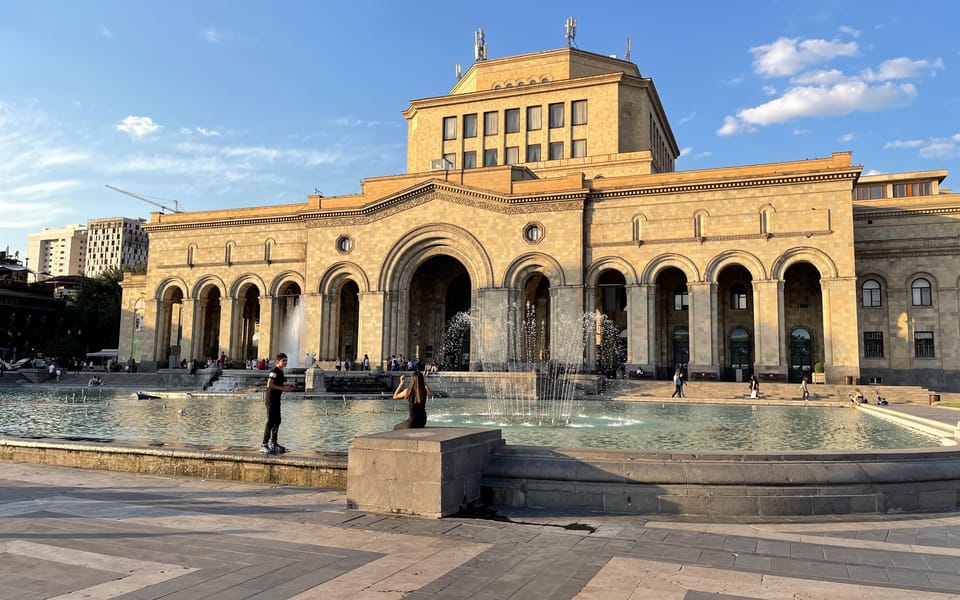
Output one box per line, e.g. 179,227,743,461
70,269,123,351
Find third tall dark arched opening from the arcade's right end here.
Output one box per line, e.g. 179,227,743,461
655,267,690,379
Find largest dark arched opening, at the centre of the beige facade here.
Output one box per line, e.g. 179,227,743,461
405,256,473,371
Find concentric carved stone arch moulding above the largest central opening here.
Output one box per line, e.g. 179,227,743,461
378,223,493,290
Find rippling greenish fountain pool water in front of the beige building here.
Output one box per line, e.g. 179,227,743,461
0,388,940,451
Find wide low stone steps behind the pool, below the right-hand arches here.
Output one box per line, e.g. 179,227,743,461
602,379,940,404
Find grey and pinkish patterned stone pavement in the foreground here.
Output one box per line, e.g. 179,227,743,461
0,462,960,600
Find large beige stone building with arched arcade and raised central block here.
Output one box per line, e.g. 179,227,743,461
120,43,960,386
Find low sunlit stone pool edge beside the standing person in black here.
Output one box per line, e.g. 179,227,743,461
0,438,347,490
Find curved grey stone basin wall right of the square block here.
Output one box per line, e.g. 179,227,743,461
483,446,960,516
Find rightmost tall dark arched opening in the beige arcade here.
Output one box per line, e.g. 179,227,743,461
783,262,824,382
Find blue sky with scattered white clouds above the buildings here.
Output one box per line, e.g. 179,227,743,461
0,0,960,255
